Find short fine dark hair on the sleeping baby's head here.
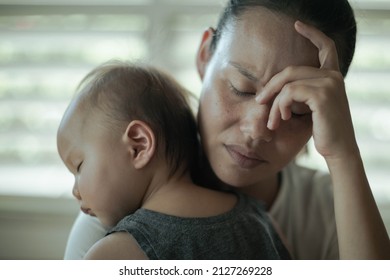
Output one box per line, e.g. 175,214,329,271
78,61,199,175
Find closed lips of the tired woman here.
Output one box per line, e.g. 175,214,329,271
225,145,267,169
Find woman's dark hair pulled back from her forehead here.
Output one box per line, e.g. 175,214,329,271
210,0,356,76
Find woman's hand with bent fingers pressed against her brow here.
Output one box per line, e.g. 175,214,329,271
256,21,358,162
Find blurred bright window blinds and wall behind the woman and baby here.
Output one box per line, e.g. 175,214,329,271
0,0,390,259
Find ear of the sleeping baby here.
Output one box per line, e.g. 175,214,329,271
122,120,156,169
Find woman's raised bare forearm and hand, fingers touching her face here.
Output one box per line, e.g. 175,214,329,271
256,20,390,259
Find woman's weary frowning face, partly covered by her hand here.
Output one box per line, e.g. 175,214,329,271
197,8,318,187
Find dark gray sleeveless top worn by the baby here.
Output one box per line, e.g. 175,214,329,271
107,194,290,260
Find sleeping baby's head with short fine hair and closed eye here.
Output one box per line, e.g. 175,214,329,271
57,61,198,225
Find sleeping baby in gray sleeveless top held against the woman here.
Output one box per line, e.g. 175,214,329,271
57,61,290,259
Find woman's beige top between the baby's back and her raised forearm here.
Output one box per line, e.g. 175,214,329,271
270,163,339,260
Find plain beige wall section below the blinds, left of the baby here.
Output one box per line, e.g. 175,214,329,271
0,196,79,260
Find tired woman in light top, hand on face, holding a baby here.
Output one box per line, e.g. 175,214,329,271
65,0,390,259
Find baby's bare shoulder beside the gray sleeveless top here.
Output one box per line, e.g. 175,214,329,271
85,232,148,260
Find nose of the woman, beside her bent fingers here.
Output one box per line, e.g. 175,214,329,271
240,103,273,142
